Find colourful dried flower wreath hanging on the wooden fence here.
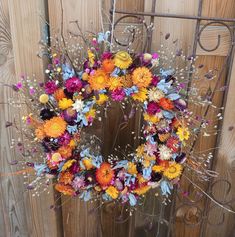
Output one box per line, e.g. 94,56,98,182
15,32,190,206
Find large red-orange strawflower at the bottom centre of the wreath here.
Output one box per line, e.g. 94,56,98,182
96,162,114,186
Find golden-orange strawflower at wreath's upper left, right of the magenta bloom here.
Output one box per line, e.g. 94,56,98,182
88,69,108,90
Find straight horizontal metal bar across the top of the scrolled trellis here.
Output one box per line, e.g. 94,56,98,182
112,10,235,22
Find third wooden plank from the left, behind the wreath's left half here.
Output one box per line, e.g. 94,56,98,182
48,0,101,237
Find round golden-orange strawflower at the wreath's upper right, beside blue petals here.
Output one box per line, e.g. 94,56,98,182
132,67,152,87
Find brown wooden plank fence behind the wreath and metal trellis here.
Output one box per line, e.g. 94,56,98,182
0,0,235,237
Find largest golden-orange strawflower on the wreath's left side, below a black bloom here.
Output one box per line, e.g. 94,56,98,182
44,117,67,138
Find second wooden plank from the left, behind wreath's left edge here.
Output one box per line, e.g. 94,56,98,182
5,0,61,236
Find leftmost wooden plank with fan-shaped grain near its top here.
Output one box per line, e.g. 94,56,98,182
0,0,29,237
